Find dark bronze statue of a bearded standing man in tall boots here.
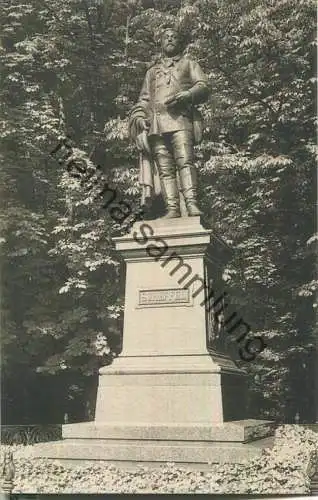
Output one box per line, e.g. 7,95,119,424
129,28,209,218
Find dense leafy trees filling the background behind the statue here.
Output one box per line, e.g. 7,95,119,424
0,0,317,420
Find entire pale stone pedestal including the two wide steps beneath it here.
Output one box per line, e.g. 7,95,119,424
33,217,273,468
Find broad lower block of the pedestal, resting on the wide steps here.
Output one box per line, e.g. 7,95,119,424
95,354,245,425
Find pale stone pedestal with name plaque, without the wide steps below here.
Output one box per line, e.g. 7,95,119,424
95,217,245,425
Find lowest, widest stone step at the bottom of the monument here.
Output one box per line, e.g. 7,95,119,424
32,438,273,466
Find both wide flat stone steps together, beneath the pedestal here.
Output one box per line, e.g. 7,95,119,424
33,420,273,470
